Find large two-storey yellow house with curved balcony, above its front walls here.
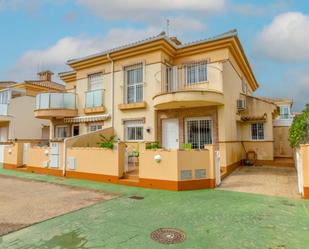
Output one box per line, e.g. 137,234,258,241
35,30,277,177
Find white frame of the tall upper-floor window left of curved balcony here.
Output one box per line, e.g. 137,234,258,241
124,63,145,104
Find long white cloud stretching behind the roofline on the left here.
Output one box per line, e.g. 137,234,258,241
5,27,159,80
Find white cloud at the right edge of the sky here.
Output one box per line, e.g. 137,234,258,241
254,12,309,62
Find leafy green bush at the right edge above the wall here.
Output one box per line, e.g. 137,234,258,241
289,104,309,148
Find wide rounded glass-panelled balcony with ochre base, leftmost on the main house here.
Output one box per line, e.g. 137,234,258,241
34,93,77,119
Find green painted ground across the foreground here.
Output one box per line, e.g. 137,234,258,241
0,166,309,249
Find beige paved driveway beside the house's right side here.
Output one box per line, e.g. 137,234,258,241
219,166,301,198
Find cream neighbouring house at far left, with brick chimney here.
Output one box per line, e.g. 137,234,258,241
0,71,64,162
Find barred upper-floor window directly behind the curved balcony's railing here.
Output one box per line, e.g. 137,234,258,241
186,62,207,85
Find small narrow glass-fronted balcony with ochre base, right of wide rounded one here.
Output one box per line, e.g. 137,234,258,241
84,89,105,114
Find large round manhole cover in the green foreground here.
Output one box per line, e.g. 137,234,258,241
150,228,186,244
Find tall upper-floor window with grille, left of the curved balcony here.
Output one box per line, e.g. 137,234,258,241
124,63,144,103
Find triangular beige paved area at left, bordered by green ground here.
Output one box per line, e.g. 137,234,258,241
0,175,115,235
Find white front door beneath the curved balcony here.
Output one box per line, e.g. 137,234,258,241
162,119,179,149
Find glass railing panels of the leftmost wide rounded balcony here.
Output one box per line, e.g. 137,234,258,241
36,93,76,110
